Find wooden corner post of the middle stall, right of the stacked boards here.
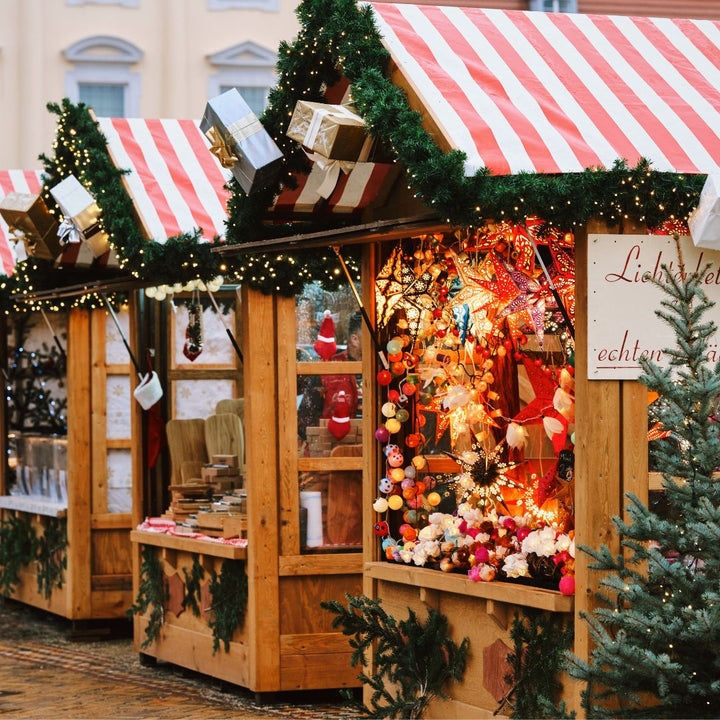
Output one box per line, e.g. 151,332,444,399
242,287,280,692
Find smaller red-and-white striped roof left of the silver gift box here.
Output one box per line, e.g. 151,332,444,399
98,118,230,243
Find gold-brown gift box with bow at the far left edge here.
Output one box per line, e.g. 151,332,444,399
0,192,62,262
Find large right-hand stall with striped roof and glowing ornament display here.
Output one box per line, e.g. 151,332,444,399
215,2,720,717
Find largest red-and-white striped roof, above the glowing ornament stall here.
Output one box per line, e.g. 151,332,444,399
371,2,720,175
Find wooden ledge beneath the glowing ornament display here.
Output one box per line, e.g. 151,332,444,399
365,562,574,613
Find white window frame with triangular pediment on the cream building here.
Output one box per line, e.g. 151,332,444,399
207,40,277,114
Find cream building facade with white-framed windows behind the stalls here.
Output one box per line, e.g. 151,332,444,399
0,0,298,170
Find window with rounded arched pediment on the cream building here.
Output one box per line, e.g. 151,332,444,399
65,35,143,117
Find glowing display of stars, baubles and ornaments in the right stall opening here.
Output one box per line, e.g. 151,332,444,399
373,232,575,593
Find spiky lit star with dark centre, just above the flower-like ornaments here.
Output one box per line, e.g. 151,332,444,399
445,441,525,512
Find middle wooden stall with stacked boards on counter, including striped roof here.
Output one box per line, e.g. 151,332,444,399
64,107,367,693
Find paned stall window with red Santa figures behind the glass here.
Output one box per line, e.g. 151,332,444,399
291,283,363,553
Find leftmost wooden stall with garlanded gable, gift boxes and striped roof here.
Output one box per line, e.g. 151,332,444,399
0,108,239,621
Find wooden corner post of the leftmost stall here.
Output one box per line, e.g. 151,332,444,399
67,308,92,619
